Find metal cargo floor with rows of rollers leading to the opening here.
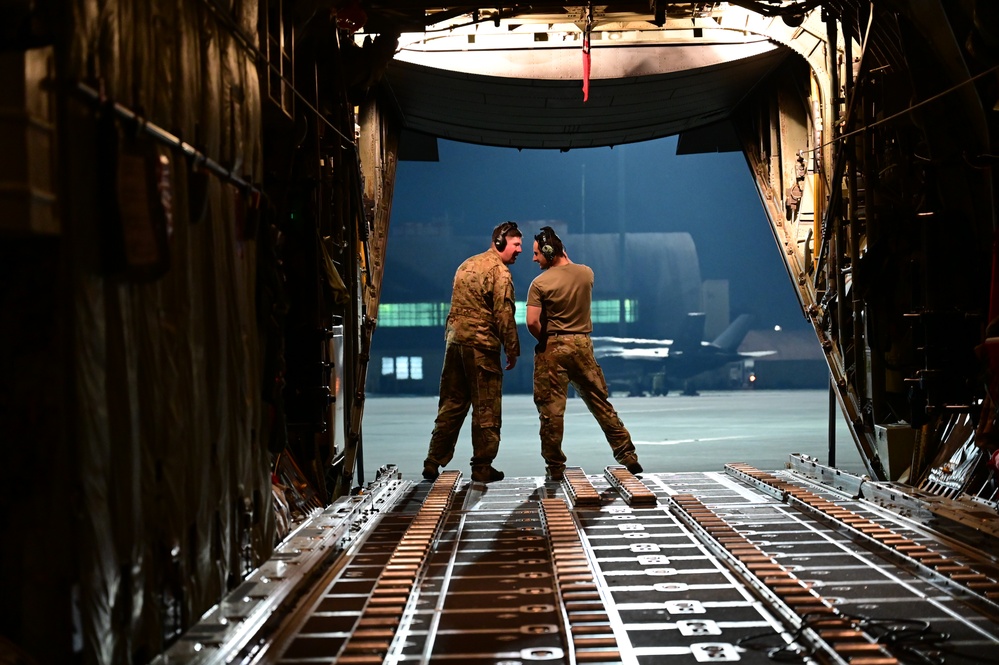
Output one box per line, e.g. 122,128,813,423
158,455,999,665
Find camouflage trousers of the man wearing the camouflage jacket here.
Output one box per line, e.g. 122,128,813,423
427,344,503,470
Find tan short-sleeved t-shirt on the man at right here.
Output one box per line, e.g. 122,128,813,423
527,263,593,335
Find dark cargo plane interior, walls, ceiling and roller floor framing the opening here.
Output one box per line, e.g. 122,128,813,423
0,0,999,664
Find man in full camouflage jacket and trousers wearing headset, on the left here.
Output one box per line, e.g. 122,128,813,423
423,222,523,483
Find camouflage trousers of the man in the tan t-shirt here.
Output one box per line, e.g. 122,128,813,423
534,335,638,471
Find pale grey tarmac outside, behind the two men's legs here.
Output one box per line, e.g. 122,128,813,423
355,390,865,484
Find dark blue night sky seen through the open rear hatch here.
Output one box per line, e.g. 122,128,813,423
386,137,808,330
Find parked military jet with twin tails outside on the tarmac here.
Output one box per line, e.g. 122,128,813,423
593,312,775,395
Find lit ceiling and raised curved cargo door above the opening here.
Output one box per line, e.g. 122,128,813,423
352,0,825,150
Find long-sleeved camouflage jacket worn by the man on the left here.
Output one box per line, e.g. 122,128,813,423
445,249,520,357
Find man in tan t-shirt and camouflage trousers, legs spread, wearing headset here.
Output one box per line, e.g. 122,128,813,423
527,226,642,480
